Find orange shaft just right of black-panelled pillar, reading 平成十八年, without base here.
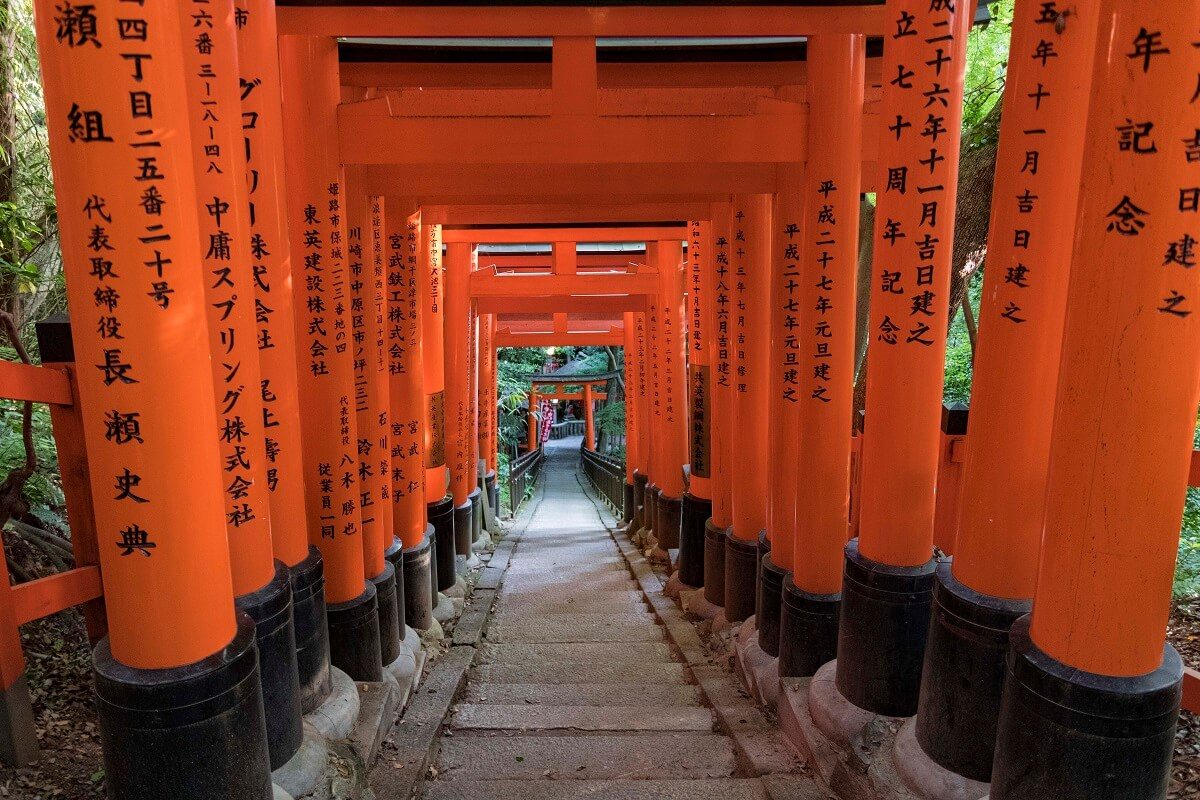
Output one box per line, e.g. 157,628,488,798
701,203,737,530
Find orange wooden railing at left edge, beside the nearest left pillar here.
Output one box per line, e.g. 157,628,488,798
0,328,108,760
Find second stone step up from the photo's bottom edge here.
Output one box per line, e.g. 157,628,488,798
437,733,737,781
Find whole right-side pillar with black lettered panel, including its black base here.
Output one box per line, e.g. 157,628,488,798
678,219,713,588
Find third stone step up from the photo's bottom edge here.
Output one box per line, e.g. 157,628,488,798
450,704,713,732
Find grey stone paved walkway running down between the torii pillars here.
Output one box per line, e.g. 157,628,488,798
422,438,767,800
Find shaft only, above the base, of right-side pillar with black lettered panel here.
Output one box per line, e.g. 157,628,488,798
685,219,713,500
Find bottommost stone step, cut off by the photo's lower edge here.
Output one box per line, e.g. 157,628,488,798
422,778,770,800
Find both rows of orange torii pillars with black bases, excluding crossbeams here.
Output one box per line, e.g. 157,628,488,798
18,0,1200,800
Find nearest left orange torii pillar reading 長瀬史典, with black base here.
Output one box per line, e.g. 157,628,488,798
37,0,272,800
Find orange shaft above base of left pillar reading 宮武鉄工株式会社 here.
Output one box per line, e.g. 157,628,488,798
383,206,427,549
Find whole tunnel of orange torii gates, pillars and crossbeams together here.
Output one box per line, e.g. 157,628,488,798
2,0,1200,800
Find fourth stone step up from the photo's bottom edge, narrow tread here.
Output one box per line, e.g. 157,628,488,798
463,681,703,705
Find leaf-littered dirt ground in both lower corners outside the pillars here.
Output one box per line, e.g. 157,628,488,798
0,599,1200,800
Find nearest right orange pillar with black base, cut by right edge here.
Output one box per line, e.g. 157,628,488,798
991,0,1200,800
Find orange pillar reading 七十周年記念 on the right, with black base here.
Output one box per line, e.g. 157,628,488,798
835,0,974,716
